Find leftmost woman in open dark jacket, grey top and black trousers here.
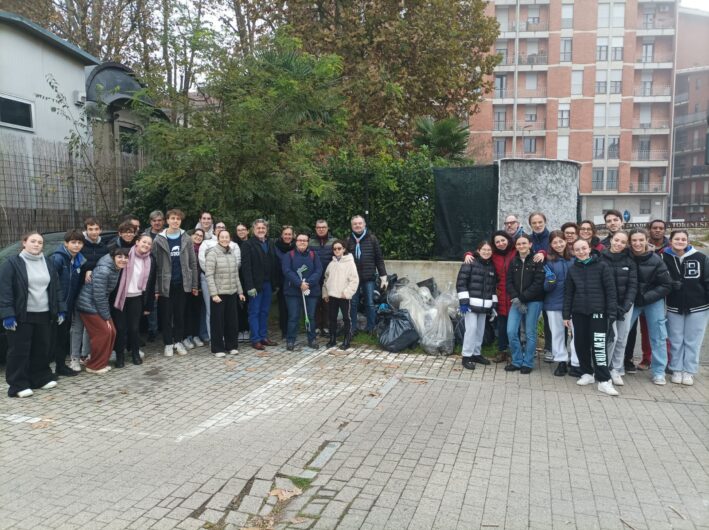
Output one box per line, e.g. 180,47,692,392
0,232,66,397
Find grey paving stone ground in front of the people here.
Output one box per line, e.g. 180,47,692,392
0,336,709,530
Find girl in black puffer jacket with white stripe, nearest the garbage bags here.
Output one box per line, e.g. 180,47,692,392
456,241,497,370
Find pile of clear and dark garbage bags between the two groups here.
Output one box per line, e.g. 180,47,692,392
377,278,458,355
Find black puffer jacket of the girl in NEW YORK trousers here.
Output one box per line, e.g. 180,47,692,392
562,256,618,320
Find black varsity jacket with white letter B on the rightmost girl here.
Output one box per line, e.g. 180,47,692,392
662,247,709,315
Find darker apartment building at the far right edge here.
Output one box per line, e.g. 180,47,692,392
671,5,709,221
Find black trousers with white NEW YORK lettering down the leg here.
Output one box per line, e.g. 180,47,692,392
571,313,611,383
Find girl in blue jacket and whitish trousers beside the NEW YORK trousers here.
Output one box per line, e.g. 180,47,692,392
544,230,581,377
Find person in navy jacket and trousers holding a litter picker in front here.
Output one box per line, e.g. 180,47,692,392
281,232,322,351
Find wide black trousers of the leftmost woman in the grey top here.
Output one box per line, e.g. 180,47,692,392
5,311,54,397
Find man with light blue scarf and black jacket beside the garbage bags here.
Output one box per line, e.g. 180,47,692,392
345,215,388,333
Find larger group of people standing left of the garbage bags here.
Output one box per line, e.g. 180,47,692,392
0,209,387,397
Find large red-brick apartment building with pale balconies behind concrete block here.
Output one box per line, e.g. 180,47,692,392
470,0,678,222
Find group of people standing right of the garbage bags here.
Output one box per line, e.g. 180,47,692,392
457,210,709,396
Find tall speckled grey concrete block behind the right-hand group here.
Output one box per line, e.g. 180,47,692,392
497,159,581,232
